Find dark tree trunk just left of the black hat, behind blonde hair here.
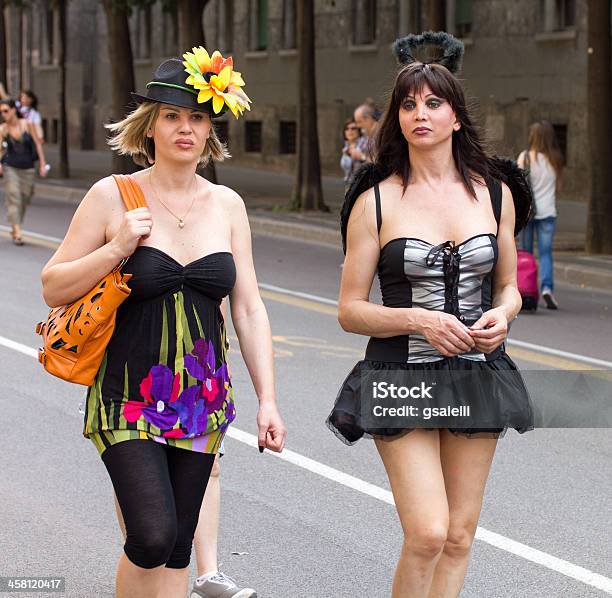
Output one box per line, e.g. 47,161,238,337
102,0,139,173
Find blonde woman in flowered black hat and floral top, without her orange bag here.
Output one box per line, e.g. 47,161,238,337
42,47,286,598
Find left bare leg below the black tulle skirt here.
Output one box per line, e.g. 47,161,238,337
376,430,449,598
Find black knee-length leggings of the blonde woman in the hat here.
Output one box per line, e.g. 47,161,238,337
102,440,215,569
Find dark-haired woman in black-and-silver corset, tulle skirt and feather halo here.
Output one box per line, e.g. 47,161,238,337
327,33,533,598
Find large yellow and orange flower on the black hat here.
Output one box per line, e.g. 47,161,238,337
183,46,251,118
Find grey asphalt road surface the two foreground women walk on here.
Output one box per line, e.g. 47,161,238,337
0,195,612,598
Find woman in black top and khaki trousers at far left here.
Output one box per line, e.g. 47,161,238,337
0,100,47,245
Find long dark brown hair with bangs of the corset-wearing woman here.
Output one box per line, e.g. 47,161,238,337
375,62,496,199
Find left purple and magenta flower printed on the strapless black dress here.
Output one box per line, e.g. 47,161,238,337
123,365,181,430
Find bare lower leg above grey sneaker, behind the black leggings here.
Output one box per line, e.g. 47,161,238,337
193,455,221,576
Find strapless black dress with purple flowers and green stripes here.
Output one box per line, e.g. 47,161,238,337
83,245,236,454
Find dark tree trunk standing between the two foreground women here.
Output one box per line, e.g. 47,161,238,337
292,0,329,212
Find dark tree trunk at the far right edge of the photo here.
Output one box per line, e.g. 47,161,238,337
586,0,612,254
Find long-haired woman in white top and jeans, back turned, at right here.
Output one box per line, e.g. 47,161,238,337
517,120,563,309
